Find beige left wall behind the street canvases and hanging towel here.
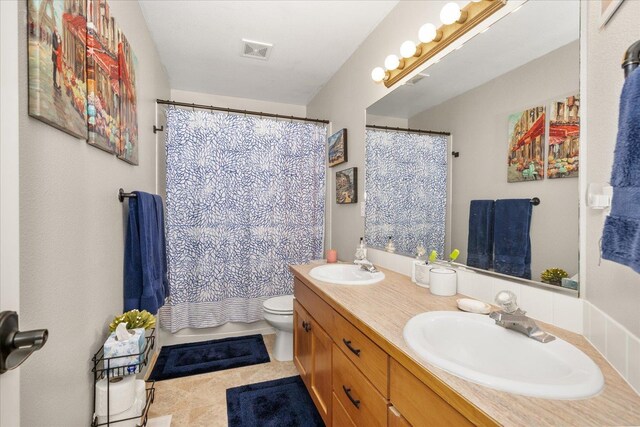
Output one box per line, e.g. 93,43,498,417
18,1,169,427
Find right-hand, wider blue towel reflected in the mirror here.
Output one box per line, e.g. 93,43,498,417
493,199,532,279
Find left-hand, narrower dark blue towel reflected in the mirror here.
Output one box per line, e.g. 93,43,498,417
467,200,495,270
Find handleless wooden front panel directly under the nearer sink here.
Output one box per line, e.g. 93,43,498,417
388,362,473,427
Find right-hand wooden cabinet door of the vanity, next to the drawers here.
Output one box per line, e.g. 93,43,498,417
309,320,332,426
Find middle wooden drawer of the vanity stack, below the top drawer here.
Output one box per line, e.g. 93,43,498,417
333,344,387,426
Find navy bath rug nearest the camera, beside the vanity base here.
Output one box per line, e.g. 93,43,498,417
227,375,324,427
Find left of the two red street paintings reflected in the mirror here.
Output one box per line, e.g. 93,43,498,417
507,107,545,182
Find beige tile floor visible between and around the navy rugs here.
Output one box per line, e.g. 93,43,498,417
149,335,298,427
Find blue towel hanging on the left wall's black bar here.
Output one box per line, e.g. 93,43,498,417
124,191,169,314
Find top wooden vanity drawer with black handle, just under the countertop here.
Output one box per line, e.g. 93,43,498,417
332,313,389,398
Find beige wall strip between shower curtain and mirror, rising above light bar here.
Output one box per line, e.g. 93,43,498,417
307,1,446,260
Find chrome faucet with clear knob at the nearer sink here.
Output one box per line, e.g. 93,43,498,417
489,291,556,343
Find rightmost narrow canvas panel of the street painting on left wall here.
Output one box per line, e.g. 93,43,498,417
116,32,138,165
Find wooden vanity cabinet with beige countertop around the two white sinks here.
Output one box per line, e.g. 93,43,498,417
291,265,640,426
